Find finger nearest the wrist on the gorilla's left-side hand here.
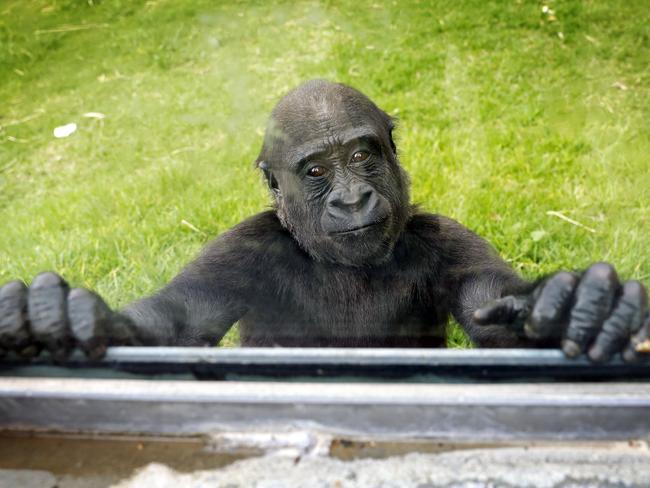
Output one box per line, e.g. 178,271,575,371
68,288,112,359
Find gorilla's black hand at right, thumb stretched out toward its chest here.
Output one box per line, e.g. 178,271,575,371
474,263,650,362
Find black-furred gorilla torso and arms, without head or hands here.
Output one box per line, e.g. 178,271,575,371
125,211,525,347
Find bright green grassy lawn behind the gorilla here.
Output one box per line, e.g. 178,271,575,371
0,0,650,345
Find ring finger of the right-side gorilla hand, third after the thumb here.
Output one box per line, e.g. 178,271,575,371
589,281,648,362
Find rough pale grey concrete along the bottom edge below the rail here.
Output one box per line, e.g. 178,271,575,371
0,443,650,488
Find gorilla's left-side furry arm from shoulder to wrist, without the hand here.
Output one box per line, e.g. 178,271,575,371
123,218,268,346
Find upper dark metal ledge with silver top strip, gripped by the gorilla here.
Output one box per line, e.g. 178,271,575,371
0,347,650,383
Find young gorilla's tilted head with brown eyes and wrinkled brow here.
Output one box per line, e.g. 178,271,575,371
257,80,410,266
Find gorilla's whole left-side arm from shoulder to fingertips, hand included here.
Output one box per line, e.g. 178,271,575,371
0,219,260,359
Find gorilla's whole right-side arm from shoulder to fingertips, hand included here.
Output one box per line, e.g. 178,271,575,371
448,222,650,362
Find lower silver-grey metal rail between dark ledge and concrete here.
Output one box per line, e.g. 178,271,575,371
0,378,650,441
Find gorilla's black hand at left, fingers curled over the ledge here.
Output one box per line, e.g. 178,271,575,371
0,272,133,359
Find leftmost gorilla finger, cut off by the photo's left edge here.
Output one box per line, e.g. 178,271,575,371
0,281,30,351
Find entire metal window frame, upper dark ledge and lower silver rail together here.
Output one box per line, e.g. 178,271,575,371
0,348,650,441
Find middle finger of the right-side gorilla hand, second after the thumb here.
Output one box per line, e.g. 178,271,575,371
562,263,620,357
